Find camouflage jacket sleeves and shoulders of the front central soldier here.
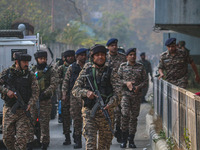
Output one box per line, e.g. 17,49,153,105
72,62,118,108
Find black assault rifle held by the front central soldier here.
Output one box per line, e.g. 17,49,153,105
83,75,114,135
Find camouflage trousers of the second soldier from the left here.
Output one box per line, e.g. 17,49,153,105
39,99,52,144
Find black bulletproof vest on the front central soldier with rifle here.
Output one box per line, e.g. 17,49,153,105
84,66,113,109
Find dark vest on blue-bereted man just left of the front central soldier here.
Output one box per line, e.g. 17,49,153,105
69,62,82,91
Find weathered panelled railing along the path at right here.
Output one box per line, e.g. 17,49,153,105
153,78,200,150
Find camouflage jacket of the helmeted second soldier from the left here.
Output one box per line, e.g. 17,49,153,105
32,66,58,96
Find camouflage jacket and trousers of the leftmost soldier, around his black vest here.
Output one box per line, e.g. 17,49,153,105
0,65,39,150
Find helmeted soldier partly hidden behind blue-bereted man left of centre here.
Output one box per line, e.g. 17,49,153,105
58,50,75,145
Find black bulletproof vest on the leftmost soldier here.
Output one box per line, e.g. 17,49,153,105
4,69,32,107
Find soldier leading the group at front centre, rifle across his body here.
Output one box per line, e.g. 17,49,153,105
72,45,118,150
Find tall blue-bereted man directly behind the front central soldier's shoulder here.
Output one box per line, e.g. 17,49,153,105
106,38,126,143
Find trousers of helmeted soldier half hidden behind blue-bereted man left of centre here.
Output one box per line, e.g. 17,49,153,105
61,98,70,135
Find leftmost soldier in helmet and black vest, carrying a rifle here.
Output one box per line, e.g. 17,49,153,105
0,52,39,150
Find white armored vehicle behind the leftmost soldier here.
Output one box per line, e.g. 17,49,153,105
0,24,39,133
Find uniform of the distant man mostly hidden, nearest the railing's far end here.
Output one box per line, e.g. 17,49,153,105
138,60,152,102
